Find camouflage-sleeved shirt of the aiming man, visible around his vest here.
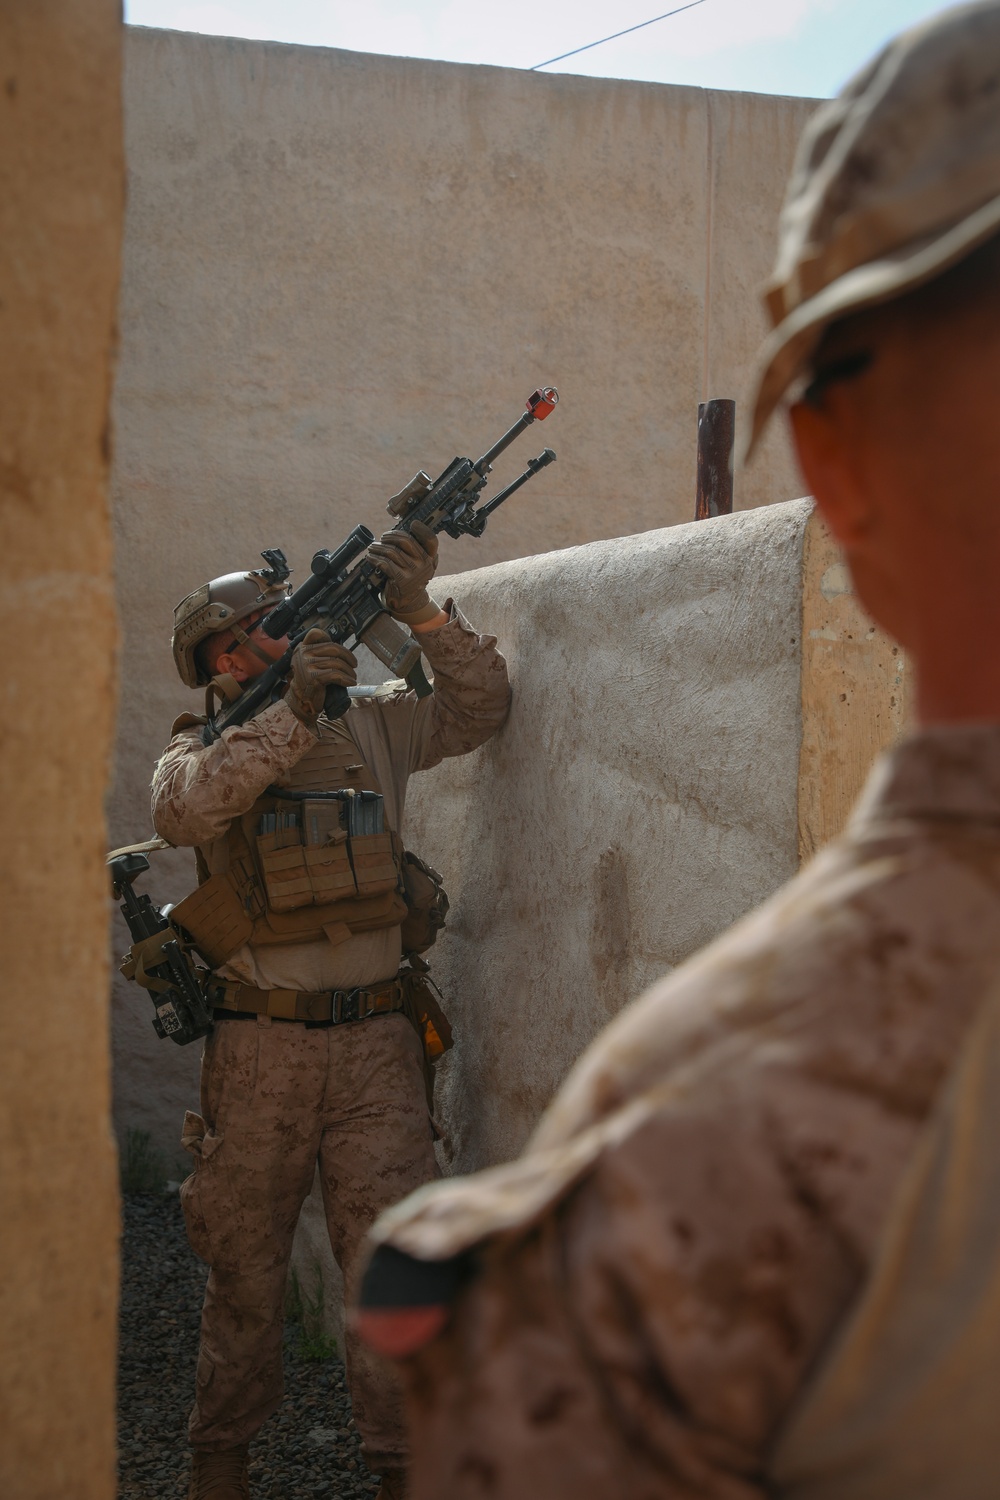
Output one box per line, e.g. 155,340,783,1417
153,600,510,993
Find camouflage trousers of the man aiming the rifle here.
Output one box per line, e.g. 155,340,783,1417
181,1014,438,1472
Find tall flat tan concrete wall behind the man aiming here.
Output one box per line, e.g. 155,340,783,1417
111,30,811,1152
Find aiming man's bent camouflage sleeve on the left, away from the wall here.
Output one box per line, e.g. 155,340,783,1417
151,704,316,848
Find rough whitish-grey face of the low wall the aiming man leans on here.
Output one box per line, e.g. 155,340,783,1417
406,501,811,1172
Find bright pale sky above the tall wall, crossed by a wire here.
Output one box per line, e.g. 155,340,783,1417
124,0,945,98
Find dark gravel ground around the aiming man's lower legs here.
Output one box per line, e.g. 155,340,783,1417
118,1194,378,1500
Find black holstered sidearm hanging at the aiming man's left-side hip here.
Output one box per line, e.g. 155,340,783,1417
108,854,211,1047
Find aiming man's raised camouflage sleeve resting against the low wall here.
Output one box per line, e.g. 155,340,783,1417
409,599,510,771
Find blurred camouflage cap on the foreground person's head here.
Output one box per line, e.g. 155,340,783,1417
745,0,1000,456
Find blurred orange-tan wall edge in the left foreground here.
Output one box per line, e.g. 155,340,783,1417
0,0,123,1500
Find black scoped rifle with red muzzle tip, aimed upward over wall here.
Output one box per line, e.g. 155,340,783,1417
201,386,559,744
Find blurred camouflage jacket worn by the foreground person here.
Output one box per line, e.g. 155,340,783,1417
375,726,1000,1500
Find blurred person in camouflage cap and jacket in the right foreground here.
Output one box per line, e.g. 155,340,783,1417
355,0,1000,1500
